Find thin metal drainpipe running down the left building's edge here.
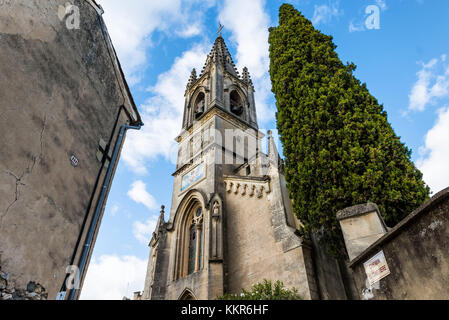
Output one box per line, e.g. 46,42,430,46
68,123,143,300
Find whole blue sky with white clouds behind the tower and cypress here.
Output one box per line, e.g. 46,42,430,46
81,0,449,299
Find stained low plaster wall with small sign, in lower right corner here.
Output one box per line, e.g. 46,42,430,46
352,188,449,300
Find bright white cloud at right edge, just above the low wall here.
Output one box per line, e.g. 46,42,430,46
417,107,449,193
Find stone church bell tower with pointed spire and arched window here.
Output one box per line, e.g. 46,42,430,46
143,35,316,299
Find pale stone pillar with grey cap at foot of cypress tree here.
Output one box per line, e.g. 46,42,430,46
337,203,388,260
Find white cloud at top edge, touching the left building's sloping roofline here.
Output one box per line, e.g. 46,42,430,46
99,0,215,84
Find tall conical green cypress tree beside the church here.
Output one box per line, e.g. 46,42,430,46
269,4,429,253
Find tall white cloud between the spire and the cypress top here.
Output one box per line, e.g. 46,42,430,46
219,0,275,124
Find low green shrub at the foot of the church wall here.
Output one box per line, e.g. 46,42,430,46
217,279,302,300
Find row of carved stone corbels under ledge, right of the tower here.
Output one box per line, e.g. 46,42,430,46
223,176,271,198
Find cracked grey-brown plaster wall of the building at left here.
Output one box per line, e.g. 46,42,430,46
0,0,138,299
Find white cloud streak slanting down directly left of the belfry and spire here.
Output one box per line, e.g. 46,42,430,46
122,44,212,174
